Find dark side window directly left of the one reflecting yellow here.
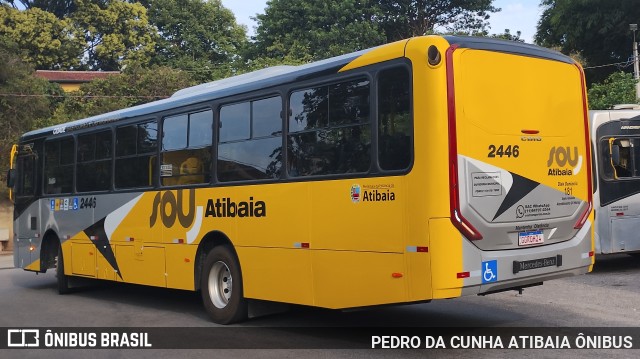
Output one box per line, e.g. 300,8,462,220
114,121,158,188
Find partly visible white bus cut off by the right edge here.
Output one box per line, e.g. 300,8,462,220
590,105,640,255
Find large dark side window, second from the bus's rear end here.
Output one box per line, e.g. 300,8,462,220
287,79,371,177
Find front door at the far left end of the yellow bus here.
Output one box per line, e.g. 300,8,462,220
12,146,40,268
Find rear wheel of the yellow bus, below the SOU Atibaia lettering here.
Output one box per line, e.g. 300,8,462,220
200,246,248,324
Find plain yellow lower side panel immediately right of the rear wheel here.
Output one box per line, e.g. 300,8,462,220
236,247,314,305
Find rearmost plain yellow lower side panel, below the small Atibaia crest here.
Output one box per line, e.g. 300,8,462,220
311,251,409,309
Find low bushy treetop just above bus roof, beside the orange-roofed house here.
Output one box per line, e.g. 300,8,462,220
50,66,195,126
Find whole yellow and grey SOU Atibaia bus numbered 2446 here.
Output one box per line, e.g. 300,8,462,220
10,36,594,323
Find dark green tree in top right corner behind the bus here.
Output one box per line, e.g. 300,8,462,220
535,0,640,82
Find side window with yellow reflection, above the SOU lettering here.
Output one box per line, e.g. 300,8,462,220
160,110,213,186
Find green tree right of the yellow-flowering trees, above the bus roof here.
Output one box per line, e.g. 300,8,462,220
145,0,247,82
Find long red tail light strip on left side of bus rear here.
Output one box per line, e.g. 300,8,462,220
446,45,482,241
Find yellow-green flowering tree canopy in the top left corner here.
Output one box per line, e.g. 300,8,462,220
0,0,157,70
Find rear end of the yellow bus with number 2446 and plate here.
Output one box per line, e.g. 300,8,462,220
442,37,593,297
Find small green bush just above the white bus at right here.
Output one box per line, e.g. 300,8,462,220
588,72,638,110
